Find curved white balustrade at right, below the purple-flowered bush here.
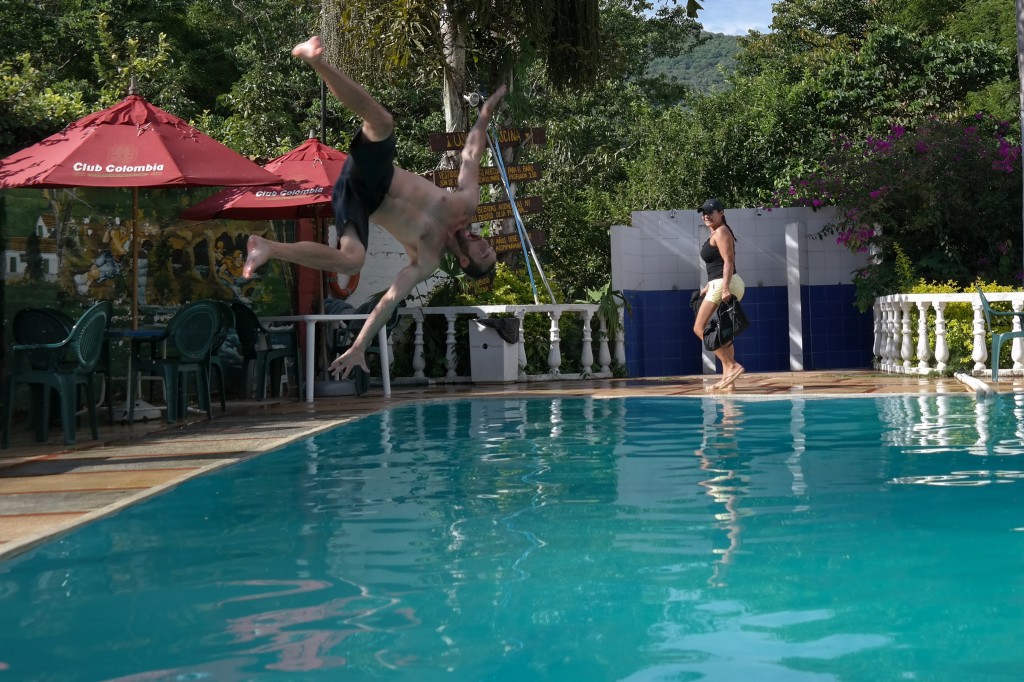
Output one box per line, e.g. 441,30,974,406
872,292,1024,375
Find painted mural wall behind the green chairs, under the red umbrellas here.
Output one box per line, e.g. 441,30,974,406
3,184,295,323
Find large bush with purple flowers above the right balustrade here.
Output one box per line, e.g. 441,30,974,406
777,115,1021,309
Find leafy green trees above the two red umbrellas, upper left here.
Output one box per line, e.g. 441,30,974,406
0,0,319,158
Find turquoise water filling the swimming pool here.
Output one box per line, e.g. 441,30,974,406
0,395,1024,682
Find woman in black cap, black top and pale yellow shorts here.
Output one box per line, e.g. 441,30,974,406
693,199,745,390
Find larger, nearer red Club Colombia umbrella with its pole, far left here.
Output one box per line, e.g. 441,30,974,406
0,79,281,329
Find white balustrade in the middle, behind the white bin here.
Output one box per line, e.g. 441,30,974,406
389,303,626,383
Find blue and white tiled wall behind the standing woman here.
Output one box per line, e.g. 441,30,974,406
611,208,872,377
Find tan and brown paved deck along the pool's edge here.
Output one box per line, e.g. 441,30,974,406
0,372,1024,558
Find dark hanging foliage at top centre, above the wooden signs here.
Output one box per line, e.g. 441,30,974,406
329,0,671,90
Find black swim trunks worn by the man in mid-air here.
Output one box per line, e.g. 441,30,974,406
331,128,395,249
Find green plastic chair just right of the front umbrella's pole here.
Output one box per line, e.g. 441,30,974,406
128,301,221,424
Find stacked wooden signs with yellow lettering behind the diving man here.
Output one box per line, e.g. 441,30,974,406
427,128,547,256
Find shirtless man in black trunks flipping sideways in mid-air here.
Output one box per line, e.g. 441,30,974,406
243,36,505,378
